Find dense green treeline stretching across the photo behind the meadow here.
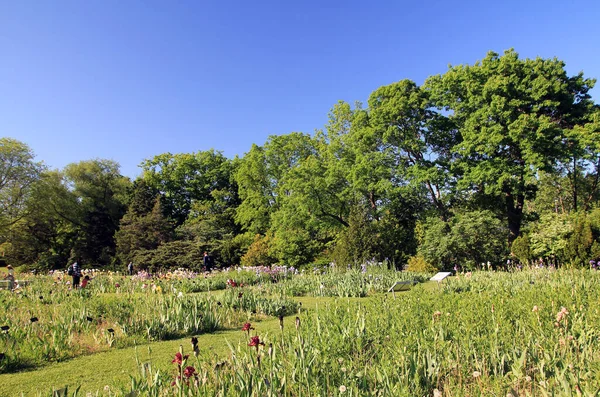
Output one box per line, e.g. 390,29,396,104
0,50,600,268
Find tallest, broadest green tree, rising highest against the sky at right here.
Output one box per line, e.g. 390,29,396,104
425,50,593,244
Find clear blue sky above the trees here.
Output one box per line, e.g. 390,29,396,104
0,0,600,177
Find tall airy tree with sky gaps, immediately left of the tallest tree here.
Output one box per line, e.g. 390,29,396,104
369,80,460,219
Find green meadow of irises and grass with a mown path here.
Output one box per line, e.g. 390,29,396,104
0,265,600,396
